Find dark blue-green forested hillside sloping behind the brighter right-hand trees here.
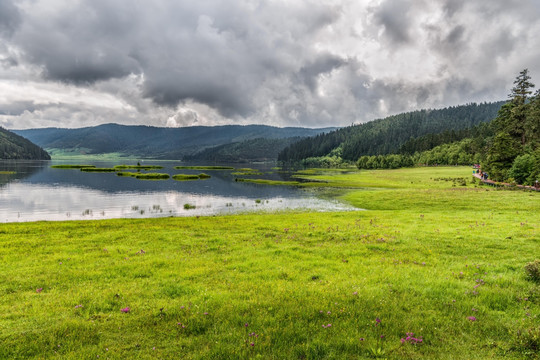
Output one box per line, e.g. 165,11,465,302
278,101,504,162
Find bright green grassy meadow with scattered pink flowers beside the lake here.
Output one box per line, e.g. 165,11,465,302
0,167,540,359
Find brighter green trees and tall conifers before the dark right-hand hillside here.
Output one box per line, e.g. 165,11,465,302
357,70,540,185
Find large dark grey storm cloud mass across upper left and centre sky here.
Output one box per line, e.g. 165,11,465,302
10,0,344,117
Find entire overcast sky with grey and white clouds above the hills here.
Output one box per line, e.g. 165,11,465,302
0,0,540,129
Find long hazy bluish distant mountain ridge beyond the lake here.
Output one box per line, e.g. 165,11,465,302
13,124,336,159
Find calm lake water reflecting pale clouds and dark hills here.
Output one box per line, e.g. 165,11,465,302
0,160,355,222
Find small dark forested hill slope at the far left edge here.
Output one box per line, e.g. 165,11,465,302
0,127,51,160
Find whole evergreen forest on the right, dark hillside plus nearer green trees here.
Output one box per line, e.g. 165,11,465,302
279,69,540,185
